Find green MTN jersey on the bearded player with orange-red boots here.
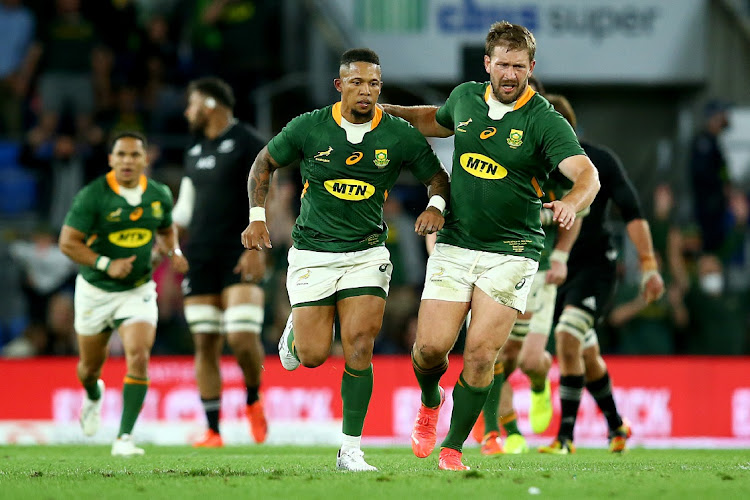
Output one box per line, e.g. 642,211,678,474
436,82,585,260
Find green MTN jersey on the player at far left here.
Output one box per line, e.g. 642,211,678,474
65,170,173,292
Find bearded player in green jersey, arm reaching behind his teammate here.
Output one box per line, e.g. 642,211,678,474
384,21,599,470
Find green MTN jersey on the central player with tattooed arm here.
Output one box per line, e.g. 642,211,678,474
268,102,442,252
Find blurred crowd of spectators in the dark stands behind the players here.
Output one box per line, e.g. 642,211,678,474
0,0,750,356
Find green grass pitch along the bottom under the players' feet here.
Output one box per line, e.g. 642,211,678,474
0,445,750,500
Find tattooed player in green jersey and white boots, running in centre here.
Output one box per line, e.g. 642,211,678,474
242,49,448,471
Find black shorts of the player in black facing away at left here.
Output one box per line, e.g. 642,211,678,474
182,249,244,297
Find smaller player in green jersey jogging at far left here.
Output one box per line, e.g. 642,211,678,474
60,132,188,456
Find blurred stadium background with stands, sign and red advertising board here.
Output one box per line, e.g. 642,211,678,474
0,0,750,446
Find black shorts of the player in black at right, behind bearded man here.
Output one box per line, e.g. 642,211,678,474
555,259,617,325
